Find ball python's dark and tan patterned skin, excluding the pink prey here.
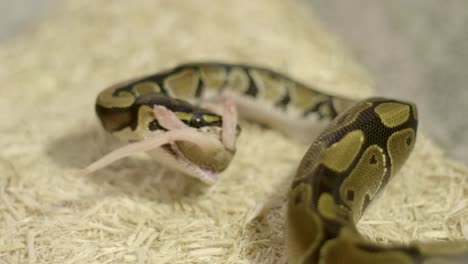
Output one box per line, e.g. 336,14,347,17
92,63,468,264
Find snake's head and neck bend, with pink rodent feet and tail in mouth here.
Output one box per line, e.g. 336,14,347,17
87,93,240,184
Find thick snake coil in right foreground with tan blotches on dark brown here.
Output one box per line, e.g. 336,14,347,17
287,98,468,264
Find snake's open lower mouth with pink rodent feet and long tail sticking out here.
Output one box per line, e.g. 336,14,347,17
79,99,237,184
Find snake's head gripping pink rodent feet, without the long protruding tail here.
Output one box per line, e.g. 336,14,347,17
144,103,240,184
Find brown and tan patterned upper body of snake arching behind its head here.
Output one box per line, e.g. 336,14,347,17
96,63,352,139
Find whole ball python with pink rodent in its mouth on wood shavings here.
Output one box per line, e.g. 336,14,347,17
82,62,468,264
